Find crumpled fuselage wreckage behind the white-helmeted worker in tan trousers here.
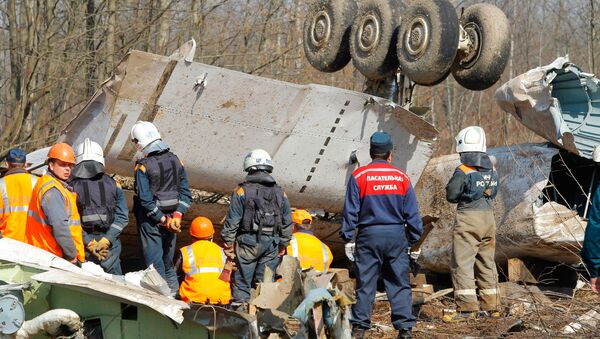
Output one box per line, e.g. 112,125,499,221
415,144,587,272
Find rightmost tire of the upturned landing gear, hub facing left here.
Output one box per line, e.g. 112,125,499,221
452,4,510,91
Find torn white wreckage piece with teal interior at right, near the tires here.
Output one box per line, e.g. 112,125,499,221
495,57,600,159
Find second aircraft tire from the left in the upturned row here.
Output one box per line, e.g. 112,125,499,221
350,0,403,80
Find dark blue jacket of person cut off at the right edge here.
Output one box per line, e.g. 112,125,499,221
581,189,600,278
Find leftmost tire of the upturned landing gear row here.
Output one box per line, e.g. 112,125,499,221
303,0,357,72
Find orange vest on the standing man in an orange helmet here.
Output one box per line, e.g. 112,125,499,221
25,174,85,262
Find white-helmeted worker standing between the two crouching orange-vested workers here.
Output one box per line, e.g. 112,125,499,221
221,149,292,310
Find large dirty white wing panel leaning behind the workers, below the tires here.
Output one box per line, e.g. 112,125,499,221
62,39,437,212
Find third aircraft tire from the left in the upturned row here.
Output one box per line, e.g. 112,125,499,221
397,0,459,86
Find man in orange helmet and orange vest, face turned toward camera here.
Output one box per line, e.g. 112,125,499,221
25,143,85,264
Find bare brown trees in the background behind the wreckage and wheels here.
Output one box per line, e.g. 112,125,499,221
0,0,600,157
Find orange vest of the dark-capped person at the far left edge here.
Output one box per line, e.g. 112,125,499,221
0,173,37,242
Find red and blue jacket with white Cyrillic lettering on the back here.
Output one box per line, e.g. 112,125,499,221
340,160,423,245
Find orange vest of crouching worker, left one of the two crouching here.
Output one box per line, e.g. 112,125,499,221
179,240,231,304
